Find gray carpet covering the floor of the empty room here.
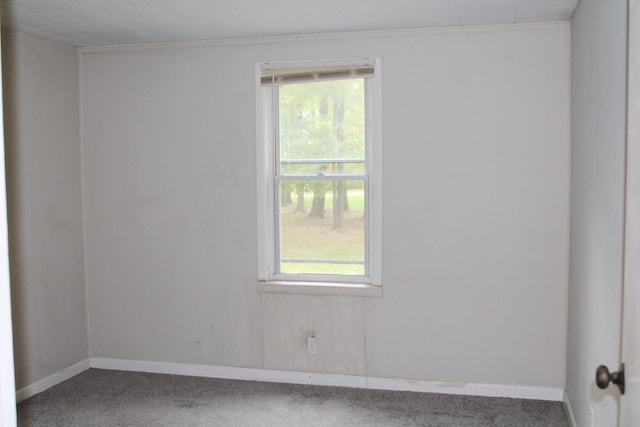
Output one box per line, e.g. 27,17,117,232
18,369,568,427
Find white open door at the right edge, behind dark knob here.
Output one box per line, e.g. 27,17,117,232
620,0,640,427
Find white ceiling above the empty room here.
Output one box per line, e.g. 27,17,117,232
2,0,578,46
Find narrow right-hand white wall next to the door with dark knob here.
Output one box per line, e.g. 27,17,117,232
567,0,627,426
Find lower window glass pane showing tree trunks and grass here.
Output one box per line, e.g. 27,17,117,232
279,180,366,275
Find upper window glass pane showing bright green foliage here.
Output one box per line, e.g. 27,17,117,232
279,78,365,165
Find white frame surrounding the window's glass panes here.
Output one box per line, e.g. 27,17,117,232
255,58,382,296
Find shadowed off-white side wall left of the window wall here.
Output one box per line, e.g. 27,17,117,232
2,32,88,388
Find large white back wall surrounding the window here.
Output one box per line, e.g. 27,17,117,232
81,24,569,388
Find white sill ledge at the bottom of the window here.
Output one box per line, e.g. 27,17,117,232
258,281,382,297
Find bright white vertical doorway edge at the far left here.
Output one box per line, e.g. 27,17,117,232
0,16,16,427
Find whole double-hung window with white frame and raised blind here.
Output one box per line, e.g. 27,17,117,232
257,59,381,292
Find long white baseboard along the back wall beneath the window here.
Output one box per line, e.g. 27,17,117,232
91,358,564,402
